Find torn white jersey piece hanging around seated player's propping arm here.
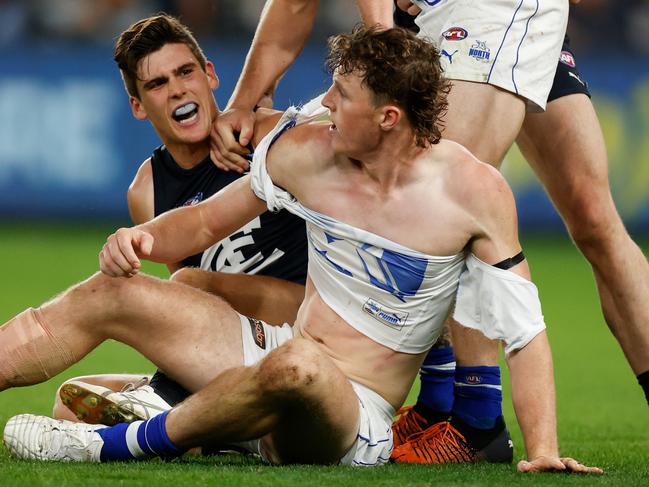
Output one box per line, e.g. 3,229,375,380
453,254,545,353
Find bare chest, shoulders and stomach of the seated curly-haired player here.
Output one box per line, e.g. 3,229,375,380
252,115,506,408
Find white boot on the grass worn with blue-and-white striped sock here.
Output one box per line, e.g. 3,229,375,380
3,414,105,462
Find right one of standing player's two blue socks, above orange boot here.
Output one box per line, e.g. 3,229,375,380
453,366,503,429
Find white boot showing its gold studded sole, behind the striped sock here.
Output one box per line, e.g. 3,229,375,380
59,381,171,426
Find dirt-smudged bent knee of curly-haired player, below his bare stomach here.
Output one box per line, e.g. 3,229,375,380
258,339,323,393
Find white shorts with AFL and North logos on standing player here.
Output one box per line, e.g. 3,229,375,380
413,0,568,111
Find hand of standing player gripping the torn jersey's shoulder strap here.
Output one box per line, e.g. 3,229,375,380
210,108,255,173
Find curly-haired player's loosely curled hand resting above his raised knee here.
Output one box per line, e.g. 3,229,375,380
99,228,153,277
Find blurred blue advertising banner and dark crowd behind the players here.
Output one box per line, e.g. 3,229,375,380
0,0,649,233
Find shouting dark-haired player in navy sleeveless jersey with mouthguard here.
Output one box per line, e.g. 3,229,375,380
54,10,307,424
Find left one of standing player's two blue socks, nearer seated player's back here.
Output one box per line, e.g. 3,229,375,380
417,347,455,413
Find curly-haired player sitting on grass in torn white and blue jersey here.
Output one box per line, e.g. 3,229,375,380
0,21,601,473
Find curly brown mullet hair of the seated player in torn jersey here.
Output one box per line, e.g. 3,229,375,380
326,25,450,147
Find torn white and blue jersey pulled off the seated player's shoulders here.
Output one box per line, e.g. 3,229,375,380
250,98,545,353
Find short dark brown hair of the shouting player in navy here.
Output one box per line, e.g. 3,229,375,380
114,13,207,98
